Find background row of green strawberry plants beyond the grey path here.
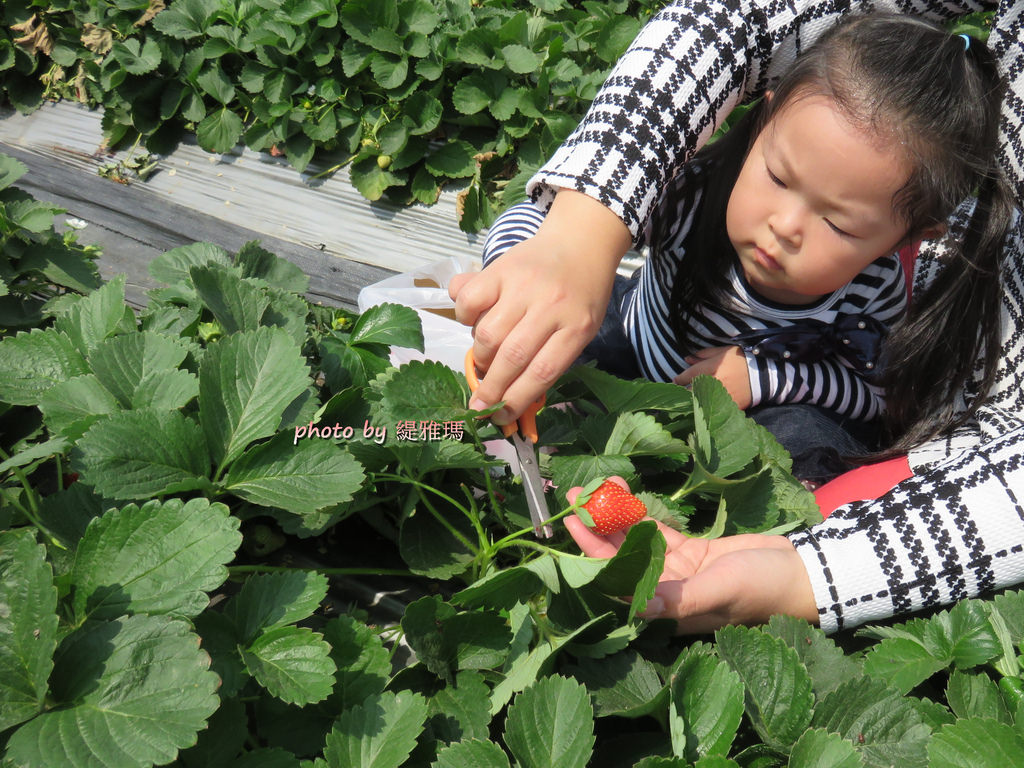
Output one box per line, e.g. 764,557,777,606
0,0,665,231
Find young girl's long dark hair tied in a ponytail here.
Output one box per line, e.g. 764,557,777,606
650,13,1014,455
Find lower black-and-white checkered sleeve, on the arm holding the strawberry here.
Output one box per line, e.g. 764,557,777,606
790,419,1024,632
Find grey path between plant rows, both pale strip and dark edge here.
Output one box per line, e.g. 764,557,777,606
0,102,640,313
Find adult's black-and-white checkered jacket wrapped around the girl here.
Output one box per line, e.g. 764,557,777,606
530,0,1024,632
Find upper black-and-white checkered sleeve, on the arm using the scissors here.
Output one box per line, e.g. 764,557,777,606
529,0,1024,243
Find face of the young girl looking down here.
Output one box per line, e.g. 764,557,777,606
726,95,910,304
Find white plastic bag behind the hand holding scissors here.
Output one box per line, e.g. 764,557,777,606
356,256,477,371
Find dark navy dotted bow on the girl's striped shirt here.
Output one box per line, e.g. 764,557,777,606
734,313,886,375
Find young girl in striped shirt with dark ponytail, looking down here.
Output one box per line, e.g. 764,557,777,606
484,14,1012,481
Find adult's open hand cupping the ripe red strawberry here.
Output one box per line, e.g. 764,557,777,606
565,477,818,634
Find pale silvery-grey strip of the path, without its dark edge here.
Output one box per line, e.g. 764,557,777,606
0,102,482,271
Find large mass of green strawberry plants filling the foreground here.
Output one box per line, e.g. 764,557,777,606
6,154,1024,768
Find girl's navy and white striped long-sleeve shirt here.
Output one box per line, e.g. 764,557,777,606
483,191,906,420
